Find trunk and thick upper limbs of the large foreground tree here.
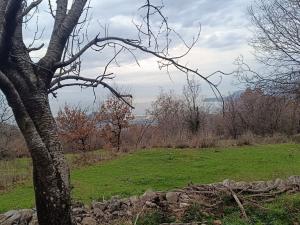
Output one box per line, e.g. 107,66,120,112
0,0,87,225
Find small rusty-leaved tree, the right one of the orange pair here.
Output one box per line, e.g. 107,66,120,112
98,96,134,151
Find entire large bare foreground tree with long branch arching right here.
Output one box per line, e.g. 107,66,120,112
0,0,224,225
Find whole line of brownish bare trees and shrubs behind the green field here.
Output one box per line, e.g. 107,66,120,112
0,79,300,158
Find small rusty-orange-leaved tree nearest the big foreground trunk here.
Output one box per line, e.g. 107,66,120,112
56,105,96,152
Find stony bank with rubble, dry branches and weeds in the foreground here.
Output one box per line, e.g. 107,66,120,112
0,176,300,225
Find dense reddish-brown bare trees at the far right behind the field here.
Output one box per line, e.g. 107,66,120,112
224,88,299,138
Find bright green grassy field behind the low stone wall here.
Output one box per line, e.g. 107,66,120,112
0,144,300,212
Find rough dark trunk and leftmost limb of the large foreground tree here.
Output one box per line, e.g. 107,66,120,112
0,0,72,222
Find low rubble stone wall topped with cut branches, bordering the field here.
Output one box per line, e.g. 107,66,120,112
0,176,300,225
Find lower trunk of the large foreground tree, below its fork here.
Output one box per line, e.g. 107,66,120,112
8,91,72,225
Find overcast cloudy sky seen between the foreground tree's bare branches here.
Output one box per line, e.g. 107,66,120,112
26,0,253,114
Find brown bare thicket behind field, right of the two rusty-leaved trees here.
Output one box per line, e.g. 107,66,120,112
141,87,300,147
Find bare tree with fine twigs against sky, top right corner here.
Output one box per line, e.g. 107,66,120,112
239,0,300,97
